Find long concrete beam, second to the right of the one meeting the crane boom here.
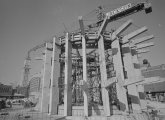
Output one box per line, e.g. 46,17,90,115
121,26,147,44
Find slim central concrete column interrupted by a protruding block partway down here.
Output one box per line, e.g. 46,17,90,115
82,36,88,116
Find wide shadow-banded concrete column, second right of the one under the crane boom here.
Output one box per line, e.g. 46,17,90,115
122,43,141,113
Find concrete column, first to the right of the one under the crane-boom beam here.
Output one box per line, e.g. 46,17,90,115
111,38,128,111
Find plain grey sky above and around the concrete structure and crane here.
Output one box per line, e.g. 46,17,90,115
0,0,165,84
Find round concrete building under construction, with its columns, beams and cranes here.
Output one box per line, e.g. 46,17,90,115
1,2,162,120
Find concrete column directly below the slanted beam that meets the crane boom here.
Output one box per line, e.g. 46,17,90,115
98,36,111,116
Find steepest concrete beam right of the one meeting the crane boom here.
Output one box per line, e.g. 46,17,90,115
111,20,132,41
